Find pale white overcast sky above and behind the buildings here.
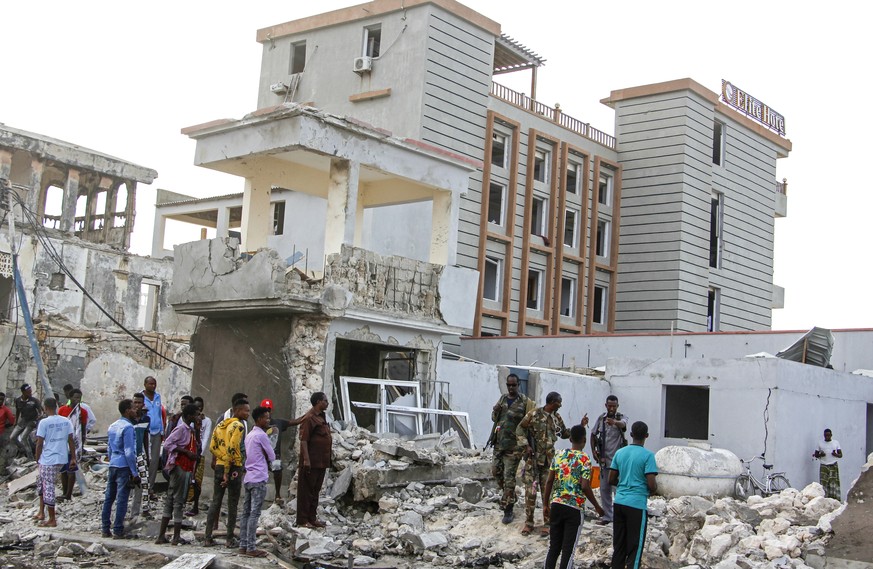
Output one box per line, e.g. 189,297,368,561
0,0,873,329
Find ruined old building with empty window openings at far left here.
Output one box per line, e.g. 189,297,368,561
0,125,194,429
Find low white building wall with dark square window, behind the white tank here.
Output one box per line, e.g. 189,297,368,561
606,358,873,496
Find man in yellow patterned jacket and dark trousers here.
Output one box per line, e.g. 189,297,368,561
205,399,250,548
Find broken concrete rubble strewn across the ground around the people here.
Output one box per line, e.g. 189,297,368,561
0,424,842,569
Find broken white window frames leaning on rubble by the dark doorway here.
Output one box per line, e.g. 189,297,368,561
339,375,474,448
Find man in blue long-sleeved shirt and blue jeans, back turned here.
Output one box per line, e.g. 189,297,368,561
102,399,139,539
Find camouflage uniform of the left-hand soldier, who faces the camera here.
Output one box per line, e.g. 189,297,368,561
491,393,533,510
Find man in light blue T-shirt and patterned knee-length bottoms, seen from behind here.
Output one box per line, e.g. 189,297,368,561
35,397,76,527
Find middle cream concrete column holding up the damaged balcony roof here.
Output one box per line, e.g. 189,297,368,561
324,158,361,255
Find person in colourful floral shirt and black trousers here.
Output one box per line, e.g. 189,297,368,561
543,425,603,569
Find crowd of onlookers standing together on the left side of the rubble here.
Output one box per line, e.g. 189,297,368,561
0,376,332,557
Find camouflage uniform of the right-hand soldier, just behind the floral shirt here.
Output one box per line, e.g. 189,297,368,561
515,407,570,526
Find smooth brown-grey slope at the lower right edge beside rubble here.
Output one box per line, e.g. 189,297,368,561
825,468,873,563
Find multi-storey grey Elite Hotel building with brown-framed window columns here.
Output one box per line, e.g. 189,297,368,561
159,0,791,336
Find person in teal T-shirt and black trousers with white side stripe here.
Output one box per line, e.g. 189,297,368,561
609,421,658,569
